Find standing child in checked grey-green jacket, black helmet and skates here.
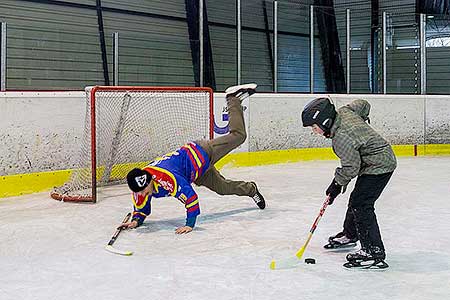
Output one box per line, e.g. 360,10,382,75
302,98,397,268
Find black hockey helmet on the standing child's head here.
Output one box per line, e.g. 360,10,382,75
302,97,336,134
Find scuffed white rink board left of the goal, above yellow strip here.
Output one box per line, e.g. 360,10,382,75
0,91,86,176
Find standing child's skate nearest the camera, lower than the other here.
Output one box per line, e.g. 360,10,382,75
344,247,389,269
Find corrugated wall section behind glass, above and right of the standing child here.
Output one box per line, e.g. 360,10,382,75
335,0,432,94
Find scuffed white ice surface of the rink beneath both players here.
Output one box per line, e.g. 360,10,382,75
0,157,450,300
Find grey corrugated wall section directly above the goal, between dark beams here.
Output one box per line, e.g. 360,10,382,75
102,0,195,86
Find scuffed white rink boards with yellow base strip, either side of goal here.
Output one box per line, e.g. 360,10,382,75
0,91,450,197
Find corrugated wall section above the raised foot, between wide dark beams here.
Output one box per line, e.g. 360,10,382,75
206,0,325,92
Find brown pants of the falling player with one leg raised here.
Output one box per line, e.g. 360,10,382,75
194,97,256,197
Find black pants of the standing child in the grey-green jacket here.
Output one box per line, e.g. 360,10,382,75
344,172,392,251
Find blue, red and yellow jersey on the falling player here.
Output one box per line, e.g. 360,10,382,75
132,142,209,227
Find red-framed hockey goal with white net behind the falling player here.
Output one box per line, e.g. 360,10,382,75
51,86,214,203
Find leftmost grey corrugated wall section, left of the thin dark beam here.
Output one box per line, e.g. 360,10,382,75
0,1,103,89
